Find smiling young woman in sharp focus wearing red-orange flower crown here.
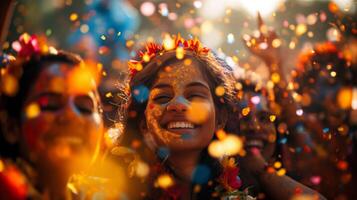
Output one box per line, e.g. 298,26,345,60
121,37,240,199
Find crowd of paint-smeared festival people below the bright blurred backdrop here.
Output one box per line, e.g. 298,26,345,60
0,13,357,199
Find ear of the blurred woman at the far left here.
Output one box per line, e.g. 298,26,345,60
2,117,21,144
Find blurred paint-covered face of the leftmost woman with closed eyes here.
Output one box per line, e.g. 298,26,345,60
21,63,103,174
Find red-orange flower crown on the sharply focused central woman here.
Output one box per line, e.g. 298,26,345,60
128,34,210,77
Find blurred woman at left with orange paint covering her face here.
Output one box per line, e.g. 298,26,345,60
0,34,103,199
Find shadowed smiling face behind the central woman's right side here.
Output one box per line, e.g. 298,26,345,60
240,92,277,160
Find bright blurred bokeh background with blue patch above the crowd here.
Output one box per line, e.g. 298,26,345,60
1,0,357,126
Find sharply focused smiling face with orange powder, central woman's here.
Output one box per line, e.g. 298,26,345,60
142,59,216,151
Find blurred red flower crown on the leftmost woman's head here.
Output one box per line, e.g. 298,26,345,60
0,33,58,96
